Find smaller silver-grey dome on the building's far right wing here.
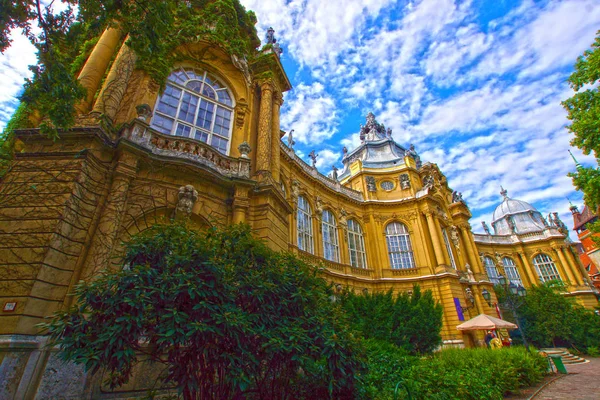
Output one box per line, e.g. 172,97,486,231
492,189,546,235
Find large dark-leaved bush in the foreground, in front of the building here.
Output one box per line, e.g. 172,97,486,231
45,224,362,399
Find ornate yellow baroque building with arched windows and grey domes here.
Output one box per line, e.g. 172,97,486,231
0,14,596,399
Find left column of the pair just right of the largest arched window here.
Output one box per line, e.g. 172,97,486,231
256,81,273,177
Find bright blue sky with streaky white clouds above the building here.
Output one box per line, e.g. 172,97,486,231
0,0,600,236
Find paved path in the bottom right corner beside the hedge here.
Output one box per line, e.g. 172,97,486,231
533,357,600,400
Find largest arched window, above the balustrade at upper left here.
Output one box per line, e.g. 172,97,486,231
151,68,234,154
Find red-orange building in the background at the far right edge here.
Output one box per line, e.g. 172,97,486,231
570,205,600,289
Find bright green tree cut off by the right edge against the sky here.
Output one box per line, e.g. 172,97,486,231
562,31,600,209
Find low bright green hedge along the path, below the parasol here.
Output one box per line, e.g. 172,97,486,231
360,341,548,400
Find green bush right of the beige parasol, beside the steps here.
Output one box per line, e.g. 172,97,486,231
519,282,600,351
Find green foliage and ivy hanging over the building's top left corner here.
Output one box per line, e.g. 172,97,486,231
0,0,260,137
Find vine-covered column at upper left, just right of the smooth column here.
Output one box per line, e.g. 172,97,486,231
94,40,137,120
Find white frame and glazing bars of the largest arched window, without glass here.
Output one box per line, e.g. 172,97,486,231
150,67,235,155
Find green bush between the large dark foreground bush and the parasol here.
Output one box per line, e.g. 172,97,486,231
342,285,442,354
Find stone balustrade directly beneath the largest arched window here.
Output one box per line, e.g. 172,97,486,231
122,120,250,179
